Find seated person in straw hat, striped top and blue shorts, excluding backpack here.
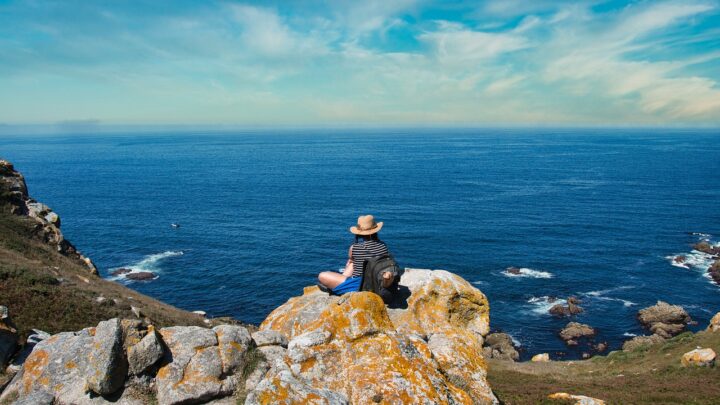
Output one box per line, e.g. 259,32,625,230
318,215,393,295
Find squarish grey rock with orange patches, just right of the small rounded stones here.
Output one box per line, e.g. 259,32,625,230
156,326,236,405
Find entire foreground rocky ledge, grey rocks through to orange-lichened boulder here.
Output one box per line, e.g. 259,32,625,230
0,269,498,405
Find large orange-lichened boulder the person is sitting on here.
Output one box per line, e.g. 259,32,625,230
255,269,497,404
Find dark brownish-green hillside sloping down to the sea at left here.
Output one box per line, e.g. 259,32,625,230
0,207,204,336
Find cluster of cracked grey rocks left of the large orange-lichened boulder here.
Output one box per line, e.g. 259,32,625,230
0,319,254,405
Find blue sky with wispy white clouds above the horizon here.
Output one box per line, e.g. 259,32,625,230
0,0,720,127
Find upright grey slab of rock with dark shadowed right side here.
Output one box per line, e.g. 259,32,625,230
87,318,127,395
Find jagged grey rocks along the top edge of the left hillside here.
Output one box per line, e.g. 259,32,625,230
0,160,98,274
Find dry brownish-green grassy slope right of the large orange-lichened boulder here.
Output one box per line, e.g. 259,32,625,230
488,332,720,404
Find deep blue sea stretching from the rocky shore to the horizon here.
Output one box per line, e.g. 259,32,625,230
0,129,720,358
